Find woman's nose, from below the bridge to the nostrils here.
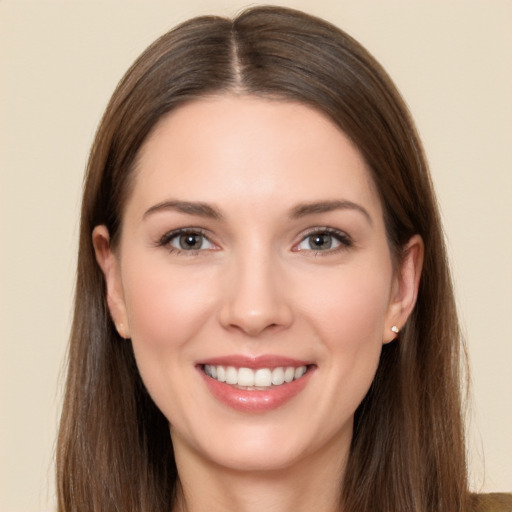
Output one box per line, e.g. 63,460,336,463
220,251,293,337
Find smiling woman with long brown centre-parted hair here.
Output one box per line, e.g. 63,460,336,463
58,8,508,511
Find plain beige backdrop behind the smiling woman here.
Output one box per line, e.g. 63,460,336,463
0,0,512,512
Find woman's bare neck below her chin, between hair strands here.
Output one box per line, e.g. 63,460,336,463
174,432,348,512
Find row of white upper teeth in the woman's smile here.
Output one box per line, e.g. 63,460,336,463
204,364,307,388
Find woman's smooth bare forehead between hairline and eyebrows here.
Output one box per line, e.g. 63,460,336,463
129,95,380,218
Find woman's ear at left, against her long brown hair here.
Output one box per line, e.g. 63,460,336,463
92,225,130,338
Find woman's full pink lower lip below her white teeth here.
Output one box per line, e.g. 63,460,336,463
199,368,313,413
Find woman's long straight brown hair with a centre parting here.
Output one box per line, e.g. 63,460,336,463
57,7,467,512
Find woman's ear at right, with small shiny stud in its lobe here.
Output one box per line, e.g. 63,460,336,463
382,235,425,343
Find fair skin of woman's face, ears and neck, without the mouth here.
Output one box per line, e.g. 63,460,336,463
93,95,423,512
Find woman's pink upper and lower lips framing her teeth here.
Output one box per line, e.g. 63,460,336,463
196,355,316,413
